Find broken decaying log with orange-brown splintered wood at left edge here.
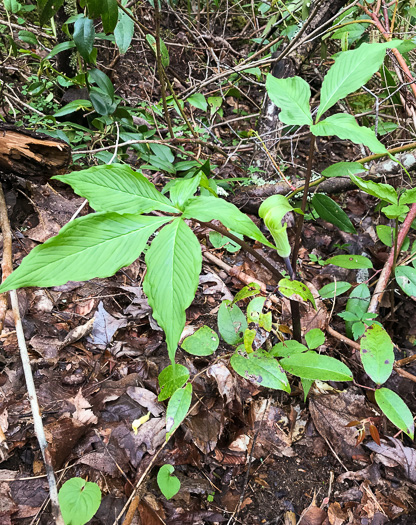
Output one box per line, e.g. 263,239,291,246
0,124,71,177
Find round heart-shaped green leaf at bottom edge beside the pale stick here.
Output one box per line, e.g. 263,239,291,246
58,478,101,525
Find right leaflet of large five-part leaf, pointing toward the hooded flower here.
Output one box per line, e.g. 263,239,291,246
183,196,274,248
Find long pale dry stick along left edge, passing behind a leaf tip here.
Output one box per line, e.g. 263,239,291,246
0,185,64,525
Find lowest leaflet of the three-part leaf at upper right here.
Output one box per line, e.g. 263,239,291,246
311,113,387,153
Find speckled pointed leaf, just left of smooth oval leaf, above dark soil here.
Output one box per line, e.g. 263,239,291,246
230,350,290,392
